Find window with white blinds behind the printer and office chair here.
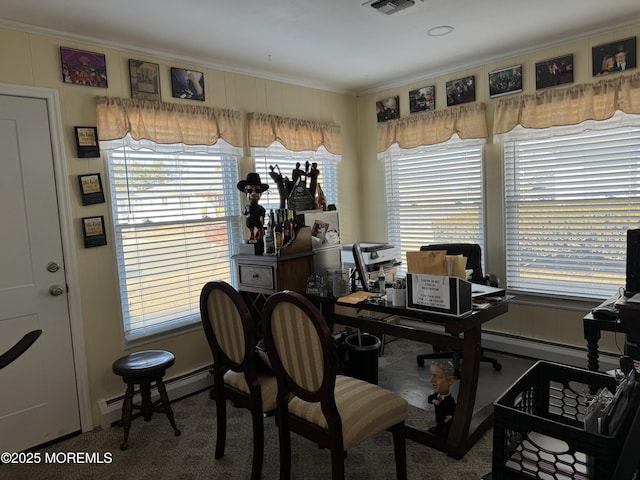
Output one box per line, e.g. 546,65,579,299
379,139,484,273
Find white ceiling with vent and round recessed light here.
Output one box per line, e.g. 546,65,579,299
0,0,640,94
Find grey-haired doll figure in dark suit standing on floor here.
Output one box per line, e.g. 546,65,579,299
427,360,456,437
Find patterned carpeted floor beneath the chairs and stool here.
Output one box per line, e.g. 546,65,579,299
0,340,510,480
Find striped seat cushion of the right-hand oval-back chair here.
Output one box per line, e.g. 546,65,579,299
289,375,408,450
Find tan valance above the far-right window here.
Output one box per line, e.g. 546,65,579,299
493,73,640,136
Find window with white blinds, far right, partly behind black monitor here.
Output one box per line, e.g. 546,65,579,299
504,121,640,299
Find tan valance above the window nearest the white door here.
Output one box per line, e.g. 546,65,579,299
97,97,242,147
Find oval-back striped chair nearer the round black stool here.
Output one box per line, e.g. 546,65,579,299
200,281,277,480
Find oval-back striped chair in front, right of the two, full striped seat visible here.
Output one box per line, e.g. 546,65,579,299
262,290,407,480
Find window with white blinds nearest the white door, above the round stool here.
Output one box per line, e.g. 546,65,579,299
107,147,242,341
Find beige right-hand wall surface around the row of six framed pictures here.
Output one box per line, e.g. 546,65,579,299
358,25,640,354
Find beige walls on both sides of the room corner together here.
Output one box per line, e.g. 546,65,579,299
0,21,640,423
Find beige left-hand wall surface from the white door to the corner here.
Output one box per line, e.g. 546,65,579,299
0,28,358,424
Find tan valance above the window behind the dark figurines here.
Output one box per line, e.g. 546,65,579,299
247,113,342,155
